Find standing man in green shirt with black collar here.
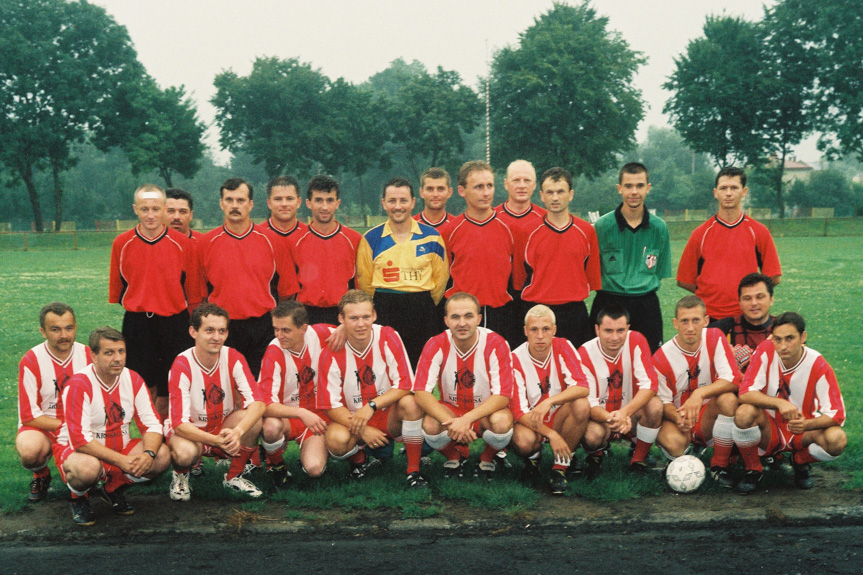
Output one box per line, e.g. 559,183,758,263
590,162,671,353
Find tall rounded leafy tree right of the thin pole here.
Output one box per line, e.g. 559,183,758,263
489,2,645,176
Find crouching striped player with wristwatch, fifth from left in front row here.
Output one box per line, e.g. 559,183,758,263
318,290,428,489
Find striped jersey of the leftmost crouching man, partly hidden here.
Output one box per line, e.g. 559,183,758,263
18,342,91,428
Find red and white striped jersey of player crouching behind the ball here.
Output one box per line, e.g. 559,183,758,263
653,327,741,407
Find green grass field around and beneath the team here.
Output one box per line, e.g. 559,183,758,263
0,237,863,518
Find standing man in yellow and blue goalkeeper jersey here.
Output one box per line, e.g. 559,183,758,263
357,178,449,365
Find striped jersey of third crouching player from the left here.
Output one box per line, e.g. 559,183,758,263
168,346,269,433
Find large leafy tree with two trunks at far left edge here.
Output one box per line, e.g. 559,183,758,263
0,0,143,231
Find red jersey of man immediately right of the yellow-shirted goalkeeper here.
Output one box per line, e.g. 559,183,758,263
440,213,514,307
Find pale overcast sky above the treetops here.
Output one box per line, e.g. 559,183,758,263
94,0,819,166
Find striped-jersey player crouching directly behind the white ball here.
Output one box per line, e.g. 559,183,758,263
653,295,741,487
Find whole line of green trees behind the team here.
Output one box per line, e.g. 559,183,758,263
0,0,863,231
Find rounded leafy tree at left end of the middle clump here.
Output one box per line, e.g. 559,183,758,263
210,58,330,177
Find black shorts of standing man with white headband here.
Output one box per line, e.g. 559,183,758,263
122,310,195,397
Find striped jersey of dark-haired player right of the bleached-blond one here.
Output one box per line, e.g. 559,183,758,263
578,330,657,412
